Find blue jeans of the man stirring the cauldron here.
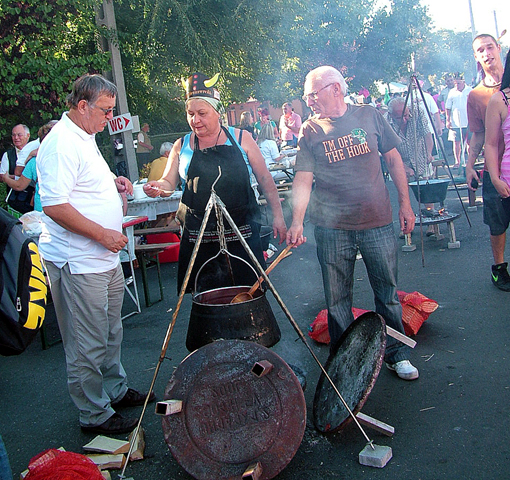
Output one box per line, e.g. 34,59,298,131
315,224,409,363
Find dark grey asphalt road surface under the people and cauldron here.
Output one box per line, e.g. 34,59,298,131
0,177,510,480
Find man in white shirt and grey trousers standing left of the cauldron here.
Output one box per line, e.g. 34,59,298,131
37,75,154,435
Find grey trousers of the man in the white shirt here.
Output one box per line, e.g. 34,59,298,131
45,262,127,426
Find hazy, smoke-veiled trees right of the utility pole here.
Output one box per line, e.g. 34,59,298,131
109,0,444,111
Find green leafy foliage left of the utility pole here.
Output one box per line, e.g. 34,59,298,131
0,0,109,148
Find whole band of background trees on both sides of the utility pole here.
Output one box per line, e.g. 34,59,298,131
0,0,488,144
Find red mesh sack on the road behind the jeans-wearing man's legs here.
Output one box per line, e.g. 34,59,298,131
308,291,438,344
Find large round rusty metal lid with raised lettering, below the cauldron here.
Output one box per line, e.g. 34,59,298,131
163,340,306,480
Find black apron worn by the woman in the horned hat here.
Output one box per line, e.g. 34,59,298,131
177,127,265,293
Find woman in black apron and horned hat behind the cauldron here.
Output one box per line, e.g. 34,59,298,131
144,73,287,292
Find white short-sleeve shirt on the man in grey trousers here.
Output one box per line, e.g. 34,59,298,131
37,113,122,274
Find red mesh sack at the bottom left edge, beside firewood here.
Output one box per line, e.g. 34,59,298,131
25,448,104,480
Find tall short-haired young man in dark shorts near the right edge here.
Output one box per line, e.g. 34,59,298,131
466,34,510,292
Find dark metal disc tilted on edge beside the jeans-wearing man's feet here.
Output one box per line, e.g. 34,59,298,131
313,312,386,433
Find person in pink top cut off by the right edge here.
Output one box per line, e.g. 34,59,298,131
485,53,510,210
